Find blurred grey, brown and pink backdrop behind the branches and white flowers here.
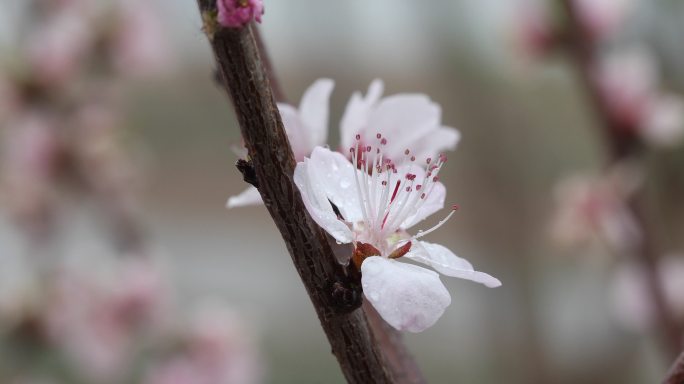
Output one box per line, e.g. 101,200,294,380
0,0,684,384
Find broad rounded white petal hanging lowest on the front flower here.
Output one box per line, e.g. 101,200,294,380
361,256,451,332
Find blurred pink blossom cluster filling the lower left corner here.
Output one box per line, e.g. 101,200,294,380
0,254,262,384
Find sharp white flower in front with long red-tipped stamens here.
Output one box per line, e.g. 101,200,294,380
294,146,501,332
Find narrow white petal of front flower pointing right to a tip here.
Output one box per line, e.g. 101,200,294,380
405,241,501,288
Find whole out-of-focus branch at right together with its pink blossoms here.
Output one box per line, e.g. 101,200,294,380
525,0,684,364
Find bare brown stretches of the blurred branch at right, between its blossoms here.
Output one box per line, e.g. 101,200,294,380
560,0,682,356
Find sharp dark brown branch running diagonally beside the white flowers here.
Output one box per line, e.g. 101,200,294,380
198,0,422,383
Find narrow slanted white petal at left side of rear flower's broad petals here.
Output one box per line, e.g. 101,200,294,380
340,79,384,150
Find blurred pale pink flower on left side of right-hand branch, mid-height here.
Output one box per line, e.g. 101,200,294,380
551,164,641,251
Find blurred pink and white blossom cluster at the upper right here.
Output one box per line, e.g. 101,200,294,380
515,0,684,148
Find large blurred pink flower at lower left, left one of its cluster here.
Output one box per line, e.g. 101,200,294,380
45,257,163,381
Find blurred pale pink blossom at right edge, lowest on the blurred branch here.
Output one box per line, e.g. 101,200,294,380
611,255,684,332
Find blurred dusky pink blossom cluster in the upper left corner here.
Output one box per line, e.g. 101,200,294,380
0,0,169,236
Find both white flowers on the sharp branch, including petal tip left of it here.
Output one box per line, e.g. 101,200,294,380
228,79,501,332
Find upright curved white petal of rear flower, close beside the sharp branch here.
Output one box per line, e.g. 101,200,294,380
299,79,335,149
